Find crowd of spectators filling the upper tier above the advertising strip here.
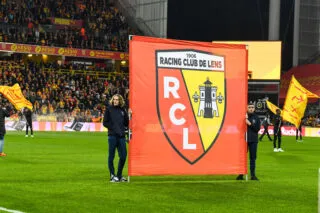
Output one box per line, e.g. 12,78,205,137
0,0,136,52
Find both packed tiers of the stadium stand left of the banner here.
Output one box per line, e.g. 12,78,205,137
0,0,133,122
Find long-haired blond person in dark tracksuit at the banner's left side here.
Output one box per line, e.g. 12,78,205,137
103,94,129,182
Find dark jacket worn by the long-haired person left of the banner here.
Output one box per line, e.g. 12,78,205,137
103,105,129,137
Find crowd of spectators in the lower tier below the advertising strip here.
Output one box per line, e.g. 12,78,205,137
0,61,129,122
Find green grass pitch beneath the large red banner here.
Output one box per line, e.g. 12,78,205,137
0,132,320,213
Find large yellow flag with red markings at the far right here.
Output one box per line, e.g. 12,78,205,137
282,76,308,128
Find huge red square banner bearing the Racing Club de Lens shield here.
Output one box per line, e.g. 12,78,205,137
129,36,248,176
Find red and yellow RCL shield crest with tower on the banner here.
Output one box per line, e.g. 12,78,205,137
156,50,226,164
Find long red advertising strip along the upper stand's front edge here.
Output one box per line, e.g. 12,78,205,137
0,42,129,60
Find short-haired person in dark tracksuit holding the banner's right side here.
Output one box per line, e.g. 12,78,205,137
237,103,261,180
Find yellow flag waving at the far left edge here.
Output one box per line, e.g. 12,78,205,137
0,84,32,110
